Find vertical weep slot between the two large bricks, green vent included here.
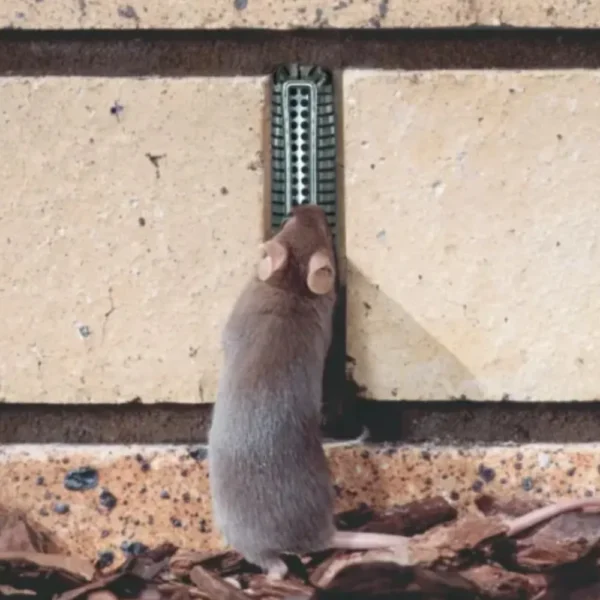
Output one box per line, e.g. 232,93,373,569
269,63,352,434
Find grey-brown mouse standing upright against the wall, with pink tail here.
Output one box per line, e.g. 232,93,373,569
207,204,407,580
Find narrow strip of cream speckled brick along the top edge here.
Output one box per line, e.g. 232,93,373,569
0,0,600,29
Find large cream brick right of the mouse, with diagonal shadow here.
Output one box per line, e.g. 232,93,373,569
344,71,600,400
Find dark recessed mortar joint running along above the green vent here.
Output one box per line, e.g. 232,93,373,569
0,28,600,77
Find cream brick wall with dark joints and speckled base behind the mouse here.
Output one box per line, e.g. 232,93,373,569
0,0,600,554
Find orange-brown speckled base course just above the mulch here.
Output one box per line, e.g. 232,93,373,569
0,444,600,560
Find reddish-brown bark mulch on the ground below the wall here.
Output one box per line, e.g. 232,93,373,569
0,496,600,600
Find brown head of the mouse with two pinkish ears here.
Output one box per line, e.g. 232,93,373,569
258,204,336,296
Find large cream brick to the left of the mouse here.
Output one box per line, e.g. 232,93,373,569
0,77,264,403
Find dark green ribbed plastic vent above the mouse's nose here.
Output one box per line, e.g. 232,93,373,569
271,65,337,236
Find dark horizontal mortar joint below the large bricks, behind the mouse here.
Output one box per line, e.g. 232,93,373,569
0,400,600,446
